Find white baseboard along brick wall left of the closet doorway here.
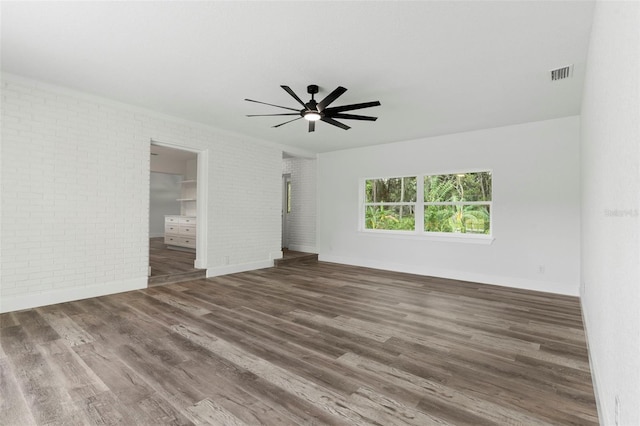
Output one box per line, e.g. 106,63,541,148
0,277,147,313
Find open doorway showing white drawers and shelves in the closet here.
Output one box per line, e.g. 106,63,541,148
149,143,206,286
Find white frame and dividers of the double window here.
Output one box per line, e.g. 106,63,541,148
358,168,495,244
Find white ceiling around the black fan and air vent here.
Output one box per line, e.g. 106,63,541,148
1,1,593,152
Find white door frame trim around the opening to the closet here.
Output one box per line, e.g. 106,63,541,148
147,138,209,269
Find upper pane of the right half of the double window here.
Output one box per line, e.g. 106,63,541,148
424,172,491,202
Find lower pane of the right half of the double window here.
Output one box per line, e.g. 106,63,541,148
424,204,491,234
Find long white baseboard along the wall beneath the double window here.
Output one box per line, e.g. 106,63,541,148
318,254,579,297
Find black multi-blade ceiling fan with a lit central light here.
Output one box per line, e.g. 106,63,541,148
245,84,380,132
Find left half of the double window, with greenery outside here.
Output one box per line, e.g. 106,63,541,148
364,176,418,231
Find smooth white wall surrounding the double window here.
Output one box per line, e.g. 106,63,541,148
318,117,580,295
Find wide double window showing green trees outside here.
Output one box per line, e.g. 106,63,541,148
361,171,492,235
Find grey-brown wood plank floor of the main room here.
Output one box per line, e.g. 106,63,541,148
0,262,597,425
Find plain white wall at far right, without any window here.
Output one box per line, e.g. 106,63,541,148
581,1,640,425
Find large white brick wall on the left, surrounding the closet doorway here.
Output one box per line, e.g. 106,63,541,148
0,75,281,312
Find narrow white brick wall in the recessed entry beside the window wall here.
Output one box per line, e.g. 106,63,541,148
282,158,317,253
